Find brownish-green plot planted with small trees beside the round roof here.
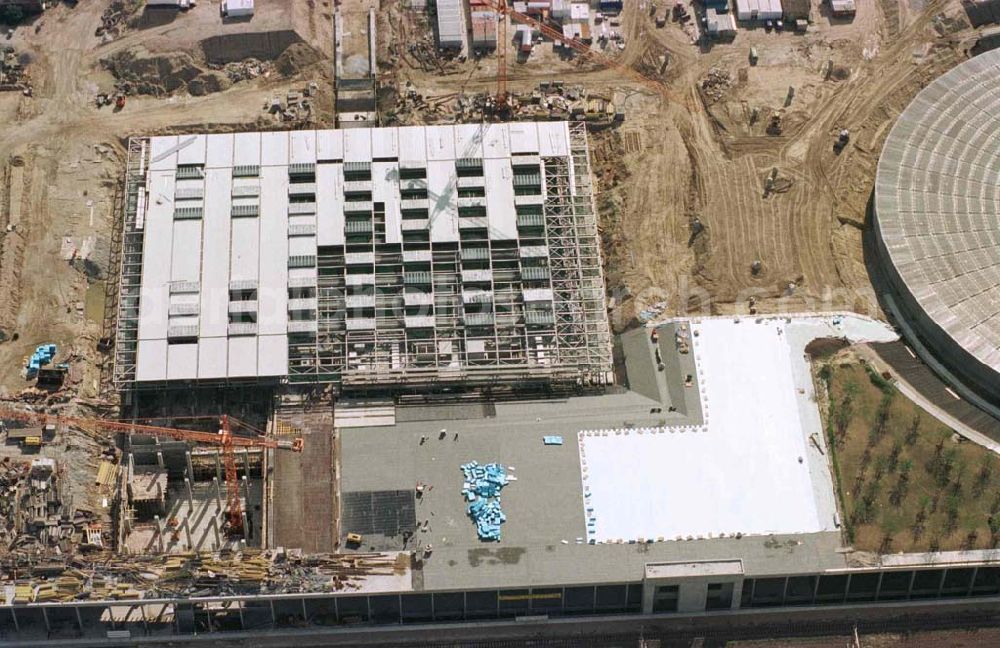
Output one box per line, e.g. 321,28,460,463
817,355,1000,553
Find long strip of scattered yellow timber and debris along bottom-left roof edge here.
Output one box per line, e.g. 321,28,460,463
0,549,411,603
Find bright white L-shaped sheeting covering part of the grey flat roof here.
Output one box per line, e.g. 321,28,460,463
580,316,896,542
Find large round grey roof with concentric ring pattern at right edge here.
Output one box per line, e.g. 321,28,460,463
875,50,1000,371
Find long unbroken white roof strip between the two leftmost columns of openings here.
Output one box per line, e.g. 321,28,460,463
201,170,232,336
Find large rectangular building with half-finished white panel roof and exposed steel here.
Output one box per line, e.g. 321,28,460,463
109,122,611,389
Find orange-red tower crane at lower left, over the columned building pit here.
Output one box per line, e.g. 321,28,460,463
0,407,303,535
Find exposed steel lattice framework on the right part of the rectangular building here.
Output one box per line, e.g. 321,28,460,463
337,124,613,388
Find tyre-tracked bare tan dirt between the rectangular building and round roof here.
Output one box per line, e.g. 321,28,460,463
382,0,968,328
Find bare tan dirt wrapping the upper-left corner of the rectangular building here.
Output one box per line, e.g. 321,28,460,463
0,0,332,398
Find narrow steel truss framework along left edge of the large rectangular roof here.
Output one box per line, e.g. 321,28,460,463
114,137,150,389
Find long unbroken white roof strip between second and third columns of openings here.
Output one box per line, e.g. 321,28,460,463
257,167,288,335
